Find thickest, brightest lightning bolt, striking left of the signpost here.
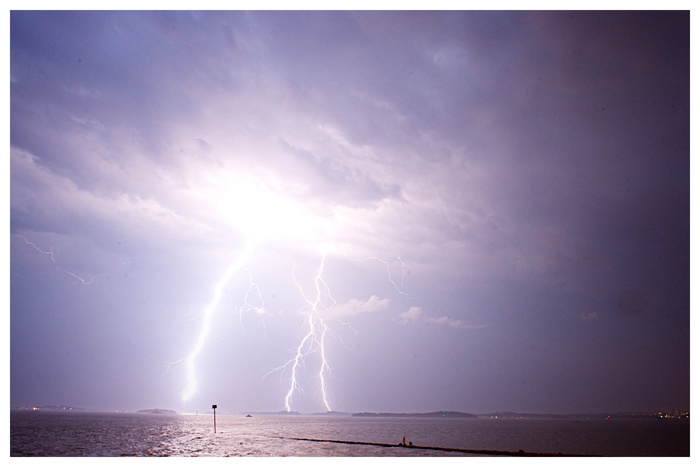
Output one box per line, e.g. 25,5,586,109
182,243,254,401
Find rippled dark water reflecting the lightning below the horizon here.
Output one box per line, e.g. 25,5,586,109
10,411,690,457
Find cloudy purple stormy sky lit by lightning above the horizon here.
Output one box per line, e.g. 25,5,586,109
10,11,690,413
